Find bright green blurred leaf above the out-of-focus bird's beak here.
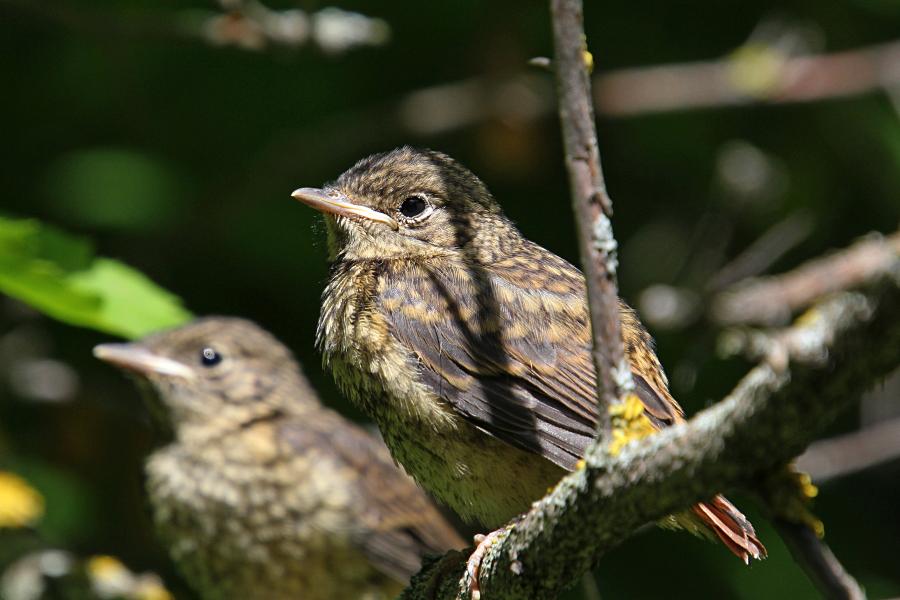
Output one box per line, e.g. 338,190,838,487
0,217,191,338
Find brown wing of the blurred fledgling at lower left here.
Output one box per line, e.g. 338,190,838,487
282,411,465,582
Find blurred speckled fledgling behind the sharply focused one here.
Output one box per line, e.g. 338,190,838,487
94,317,465,600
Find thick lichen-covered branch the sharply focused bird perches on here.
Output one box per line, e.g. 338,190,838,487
404,270,900,600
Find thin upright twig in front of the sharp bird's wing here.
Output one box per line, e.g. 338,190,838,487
550,0,632,436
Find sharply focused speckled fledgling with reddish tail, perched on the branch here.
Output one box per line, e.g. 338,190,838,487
293,147,766,562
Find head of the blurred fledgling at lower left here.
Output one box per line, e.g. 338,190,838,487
94,317,316,437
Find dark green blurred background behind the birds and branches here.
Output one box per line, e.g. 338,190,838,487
0,0,900,599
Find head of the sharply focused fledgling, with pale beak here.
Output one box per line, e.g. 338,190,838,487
292,146,519,260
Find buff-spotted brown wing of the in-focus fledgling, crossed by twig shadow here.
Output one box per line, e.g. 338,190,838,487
381,241,681,469
